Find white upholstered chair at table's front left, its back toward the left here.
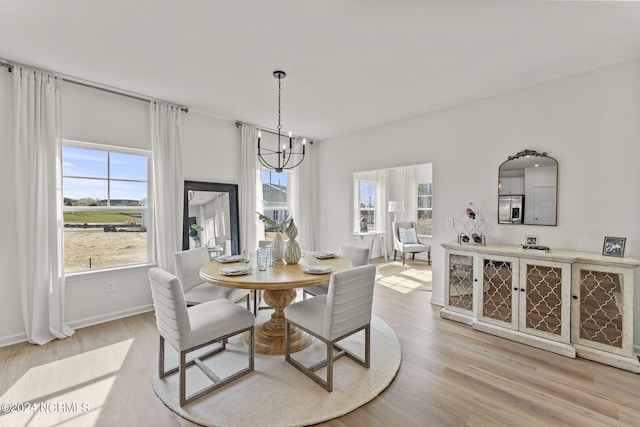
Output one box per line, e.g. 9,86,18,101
149,267,255,406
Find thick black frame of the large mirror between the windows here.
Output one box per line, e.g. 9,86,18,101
182,181,240,255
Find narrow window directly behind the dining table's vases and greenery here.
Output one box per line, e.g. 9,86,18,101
262,170,289,240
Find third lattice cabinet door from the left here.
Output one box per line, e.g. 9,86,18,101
518,258,571,343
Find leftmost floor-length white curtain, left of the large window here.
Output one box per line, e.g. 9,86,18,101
13,66,74,344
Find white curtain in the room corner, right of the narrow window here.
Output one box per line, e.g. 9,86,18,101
291,137,317,251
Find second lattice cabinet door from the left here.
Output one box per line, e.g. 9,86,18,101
477,255,519,329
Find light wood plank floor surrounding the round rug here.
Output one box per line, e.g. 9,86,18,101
0,272,640,427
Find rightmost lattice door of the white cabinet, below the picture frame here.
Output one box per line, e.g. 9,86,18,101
571,263,637,362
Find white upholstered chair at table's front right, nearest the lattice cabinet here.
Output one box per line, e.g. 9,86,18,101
284,265,376,391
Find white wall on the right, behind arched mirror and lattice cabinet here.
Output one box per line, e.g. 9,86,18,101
316,61,640,345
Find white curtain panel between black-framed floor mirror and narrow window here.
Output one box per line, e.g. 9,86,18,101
238,124,264,252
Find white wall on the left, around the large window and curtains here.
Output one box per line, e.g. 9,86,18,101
0,69,240,346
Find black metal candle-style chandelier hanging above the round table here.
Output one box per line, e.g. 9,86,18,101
258,71,307,172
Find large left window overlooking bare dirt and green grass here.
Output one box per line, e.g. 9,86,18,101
62,141,149,272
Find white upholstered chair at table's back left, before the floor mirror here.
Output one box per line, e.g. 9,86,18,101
174,247,251,309
